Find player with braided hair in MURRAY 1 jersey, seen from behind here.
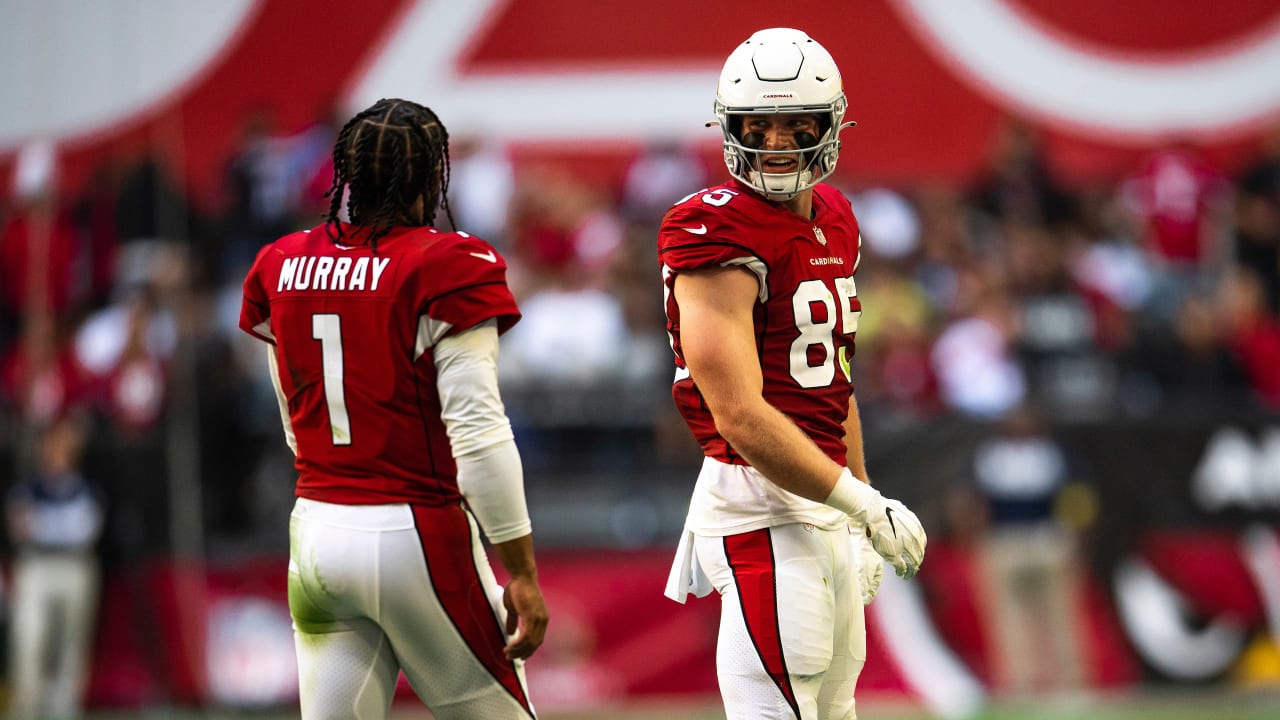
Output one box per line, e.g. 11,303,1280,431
241,100,547,720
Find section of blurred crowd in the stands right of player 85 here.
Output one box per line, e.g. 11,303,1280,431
854,122,1280,421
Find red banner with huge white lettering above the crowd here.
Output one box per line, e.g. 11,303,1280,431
0,0,1280,200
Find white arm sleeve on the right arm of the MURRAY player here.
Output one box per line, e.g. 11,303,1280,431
431,320,532,543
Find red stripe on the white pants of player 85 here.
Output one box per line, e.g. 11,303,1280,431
724,528,800,717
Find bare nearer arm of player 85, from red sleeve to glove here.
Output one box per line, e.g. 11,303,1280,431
675,260,842,502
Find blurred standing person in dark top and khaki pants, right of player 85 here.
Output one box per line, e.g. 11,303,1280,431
973,405,1085,697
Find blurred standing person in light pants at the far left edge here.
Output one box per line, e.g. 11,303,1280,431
6,414,104,720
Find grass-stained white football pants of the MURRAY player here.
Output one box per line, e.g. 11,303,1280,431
289,498,534,720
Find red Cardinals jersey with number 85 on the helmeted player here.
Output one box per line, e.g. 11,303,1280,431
658,181,861,465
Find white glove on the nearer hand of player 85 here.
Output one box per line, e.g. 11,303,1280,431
827,468,928,580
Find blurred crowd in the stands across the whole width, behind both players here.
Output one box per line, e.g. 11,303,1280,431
0,113,1280,552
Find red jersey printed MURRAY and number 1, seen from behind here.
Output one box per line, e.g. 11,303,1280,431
239,225,520,505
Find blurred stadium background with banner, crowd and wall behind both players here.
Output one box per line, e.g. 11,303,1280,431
0,0,1280,717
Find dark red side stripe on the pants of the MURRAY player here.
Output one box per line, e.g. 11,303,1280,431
413,505,534,717
